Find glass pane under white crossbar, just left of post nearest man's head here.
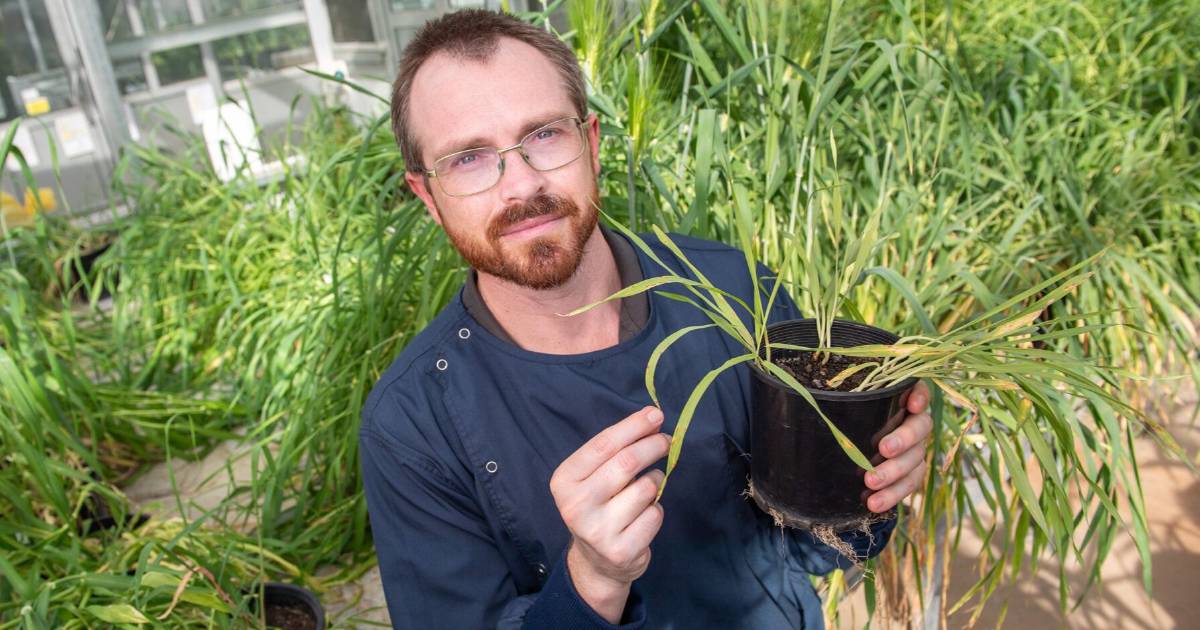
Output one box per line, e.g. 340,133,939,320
212,24,313,80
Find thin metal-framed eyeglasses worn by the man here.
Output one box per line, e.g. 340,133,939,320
425,116,584,197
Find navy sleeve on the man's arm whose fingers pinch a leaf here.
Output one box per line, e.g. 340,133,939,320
359,416,646,630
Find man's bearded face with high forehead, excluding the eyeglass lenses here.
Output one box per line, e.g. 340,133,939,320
407,38,609,289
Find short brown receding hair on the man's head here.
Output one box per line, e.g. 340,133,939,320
391,8,588,172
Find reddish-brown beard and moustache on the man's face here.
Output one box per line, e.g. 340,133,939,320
446,194,599,290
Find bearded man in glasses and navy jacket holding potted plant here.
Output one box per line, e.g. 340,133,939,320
360,11,931,629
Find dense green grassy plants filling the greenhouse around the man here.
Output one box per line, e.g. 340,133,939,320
0,0,1200,628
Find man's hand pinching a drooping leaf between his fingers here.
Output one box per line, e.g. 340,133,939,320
550,407,671,624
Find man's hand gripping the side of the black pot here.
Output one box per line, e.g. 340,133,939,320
866,380,934,512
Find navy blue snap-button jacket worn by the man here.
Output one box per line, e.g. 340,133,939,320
360,236,894,630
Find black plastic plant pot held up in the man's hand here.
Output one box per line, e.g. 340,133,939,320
750,319,917,532
